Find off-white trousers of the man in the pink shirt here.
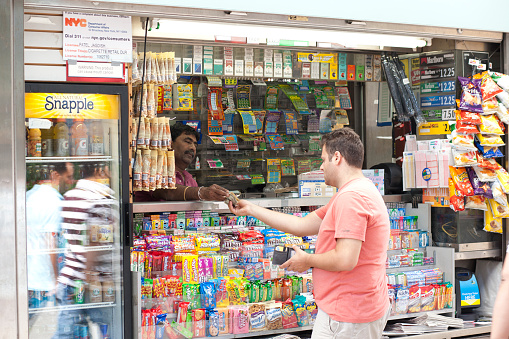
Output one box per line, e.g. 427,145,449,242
311,307,390,339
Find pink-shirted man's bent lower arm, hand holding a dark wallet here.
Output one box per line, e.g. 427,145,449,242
281,238,362,272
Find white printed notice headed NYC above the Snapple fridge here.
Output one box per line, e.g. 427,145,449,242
63,12,132,63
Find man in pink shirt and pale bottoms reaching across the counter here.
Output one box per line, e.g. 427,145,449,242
230,128,389,339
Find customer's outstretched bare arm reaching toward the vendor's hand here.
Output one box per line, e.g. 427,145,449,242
229,200,322,237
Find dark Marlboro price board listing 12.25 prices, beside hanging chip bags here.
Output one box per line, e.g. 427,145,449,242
419,52,457,121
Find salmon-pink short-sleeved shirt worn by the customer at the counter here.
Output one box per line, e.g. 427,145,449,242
313,178,389,323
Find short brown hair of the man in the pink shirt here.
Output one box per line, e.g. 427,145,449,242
322,127,364,168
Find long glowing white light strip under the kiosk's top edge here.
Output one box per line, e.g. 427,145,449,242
142,19,431,49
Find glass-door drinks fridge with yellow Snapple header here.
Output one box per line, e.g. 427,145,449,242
25,83,132,339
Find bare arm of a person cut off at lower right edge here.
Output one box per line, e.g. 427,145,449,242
491,256,509,339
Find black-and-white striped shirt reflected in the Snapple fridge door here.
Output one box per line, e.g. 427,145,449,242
58,179,117,286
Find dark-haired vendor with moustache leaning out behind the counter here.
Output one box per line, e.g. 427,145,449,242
134,122,230,202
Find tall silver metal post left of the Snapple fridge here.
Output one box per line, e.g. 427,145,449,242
0,0,28,339
